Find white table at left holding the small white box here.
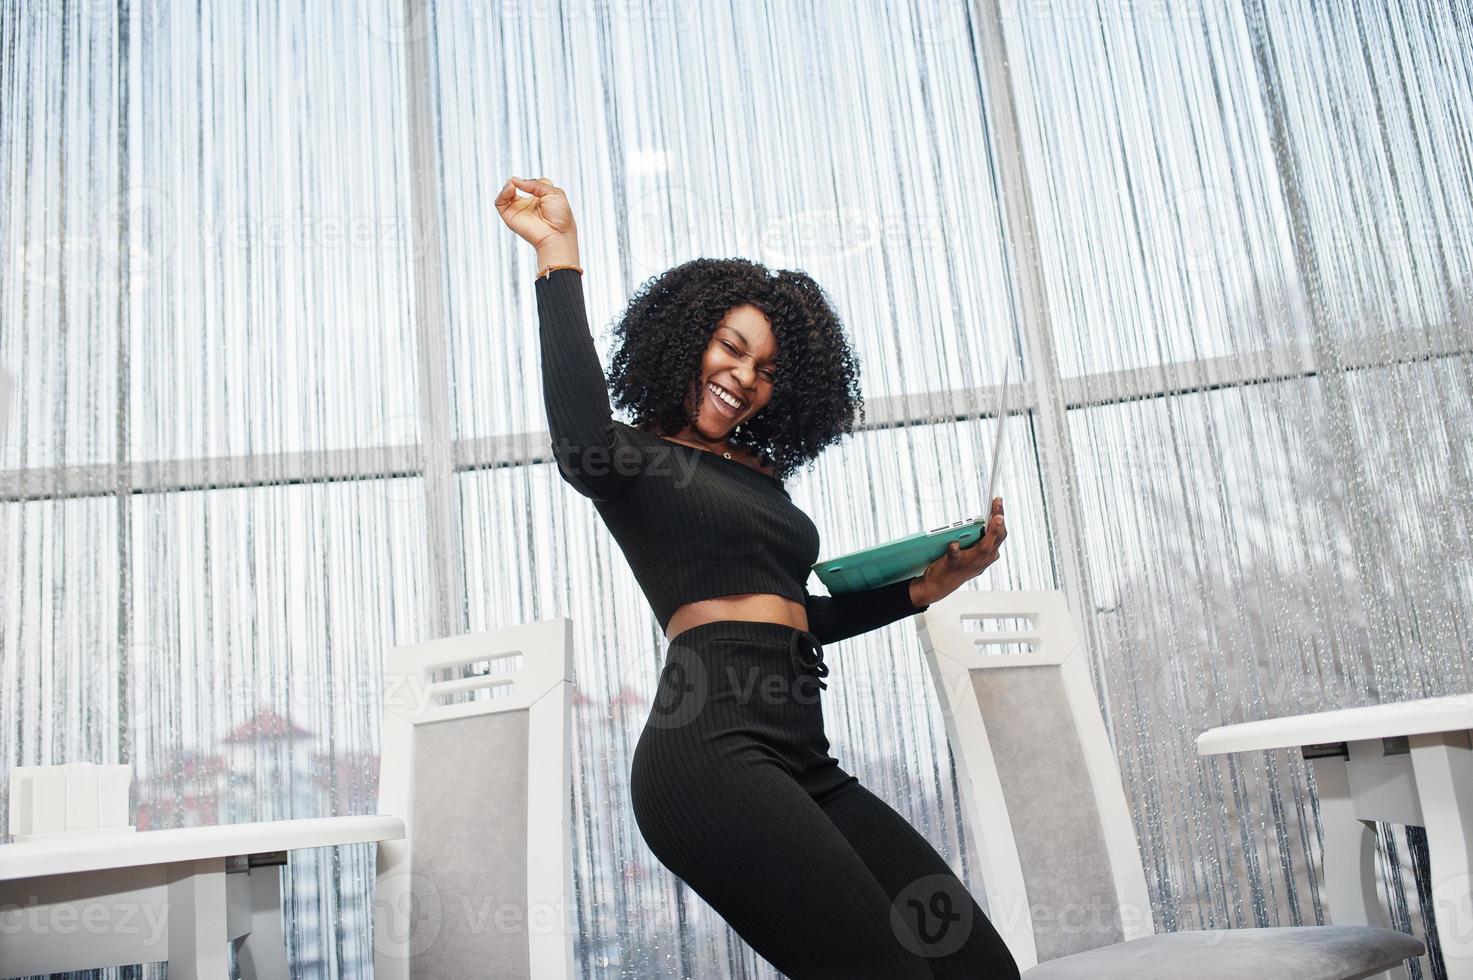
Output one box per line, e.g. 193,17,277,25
0,816,404,980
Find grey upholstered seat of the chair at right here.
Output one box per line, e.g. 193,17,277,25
1022,925,1426,980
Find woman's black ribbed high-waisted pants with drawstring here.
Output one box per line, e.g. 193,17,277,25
630,619,1018,980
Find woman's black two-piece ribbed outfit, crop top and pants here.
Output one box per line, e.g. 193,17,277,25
535,263,1018,980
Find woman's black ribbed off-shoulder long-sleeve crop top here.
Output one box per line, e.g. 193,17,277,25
535,268,929,643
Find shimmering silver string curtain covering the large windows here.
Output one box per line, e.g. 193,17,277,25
0,0,1473,977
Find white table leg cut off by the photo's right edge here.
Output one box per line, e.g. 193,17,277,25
1408,731,1473,980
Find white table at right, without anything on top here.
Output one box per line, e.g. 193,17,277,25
1198,694,1473,980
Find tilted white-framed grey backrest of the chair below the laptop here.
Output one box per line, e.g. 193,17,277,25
918,588,1155,970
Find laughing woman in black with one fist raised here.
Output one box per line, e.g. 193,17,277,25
496,177,1018,980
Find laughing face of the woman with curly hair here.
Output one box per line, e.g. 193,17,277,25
692,304,778,442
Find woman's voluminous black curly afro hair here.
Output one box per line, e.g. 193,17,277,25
608,258,865,480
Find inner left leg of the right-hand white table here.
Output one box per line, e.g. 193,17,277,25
1309,756,1402,980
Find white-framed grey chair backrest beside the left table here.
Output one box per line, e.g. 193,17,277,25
373,617,576,980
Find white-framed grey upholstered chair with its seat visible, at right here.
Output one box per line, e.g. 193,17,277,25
918,588,1424,980
